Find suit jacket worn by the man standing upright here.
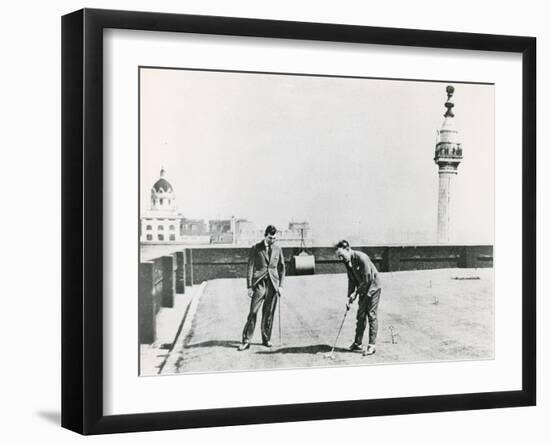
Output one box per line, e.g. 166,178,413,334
246,241,285,289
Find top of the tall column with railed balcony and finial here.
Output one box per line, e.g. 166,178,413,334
434,85,462,170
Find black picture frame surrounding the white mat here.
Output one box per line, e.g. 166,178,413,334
62,9,536,434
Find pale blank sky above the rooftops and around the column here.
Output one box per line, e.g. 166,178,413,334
140,68,494,244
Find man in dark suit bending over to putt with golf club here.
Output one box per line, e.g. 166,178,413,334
336,240,382,355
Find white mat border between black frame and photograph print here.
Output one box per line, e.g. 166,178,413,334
103,30,522,415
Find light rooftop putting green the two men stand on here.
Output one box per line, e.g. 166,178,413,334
158,269,494,374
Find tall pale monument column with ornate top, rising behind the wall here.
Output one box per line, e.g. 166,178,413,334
434,86,462,243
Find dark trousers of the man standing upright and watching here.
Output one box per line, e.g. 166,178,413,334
243,277,277,343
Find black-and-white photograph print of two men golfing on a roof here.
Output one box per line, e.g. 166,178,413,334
136,67,495,376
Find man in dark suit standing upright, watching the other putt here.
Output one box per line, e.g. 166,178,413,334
238,225,285,351
